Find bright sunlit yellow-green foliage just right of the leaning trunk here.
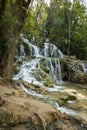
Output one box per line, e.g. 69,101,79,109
23,0,47,43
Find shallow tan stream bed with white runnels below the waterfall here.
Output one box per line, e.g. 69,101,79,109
21,83,87,121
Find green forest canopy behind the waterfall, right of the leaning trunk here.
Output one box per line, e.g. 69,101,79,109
24,0,87,59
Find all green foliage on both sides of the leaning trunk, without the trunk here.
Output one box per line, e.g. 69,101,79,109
0,0,87,64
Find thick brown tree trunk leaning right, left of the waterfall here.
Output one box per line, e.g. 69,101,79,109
2,0,31,80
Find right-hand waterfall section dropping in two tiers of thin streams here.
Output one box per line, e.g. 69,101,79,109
43,43,64,83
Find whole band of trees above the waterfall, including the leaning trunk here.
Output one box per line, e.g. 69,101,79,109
0,0,87,79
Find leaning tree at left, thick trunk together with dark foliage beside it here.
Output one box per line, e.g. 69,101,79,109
0,0,31,79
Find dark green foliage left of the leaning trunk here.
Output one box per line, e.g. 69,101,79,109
0,0,19,60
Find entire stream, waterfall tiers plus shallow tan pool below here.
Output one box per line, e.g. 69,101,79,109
13,35,87,121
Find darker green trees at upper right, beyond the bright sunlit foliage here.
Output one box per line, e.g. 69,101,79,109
46,0,87,58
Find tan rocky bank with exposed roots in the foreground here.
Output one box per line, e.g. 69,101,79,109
0,82,87,130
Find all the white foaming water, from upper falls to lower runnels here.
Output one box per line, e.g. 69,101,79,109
13,35,87,121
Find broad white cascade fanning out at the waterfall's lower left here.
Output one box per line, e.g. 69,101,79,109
13,58,43,86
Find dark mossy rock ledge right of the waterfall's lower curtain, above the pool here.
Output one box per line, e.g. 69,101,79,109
60,57,87,84
